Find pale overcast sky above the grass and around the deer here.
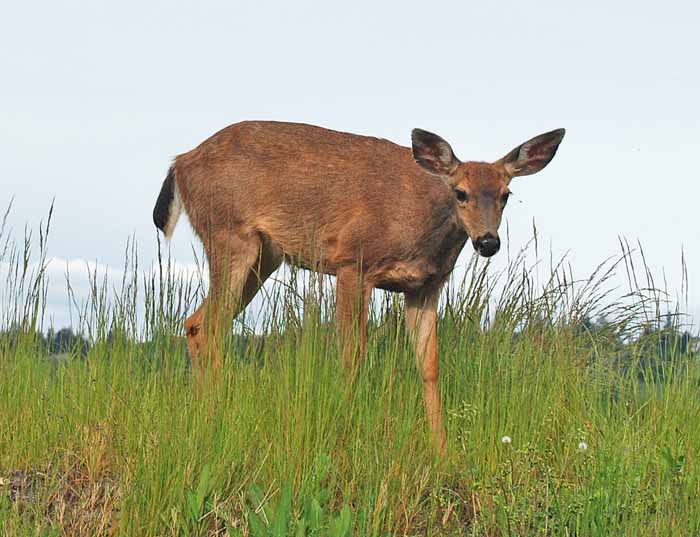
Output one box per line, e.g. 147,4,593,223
0,0,700,325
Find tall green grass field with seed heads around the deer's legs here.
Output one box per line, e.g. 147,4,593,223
0,216,700,537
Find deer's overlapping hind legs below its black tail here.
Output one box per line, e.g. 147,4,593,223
185,233,280,384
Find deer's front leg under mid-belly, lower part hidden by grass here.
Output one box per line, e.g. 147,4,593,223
335,267,372,370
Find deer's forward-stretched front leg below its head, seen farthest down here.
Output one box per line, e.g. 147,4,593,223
406,289,447,455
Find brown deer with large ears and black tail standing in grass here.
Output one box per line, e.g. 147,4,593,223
153,121,564,452
